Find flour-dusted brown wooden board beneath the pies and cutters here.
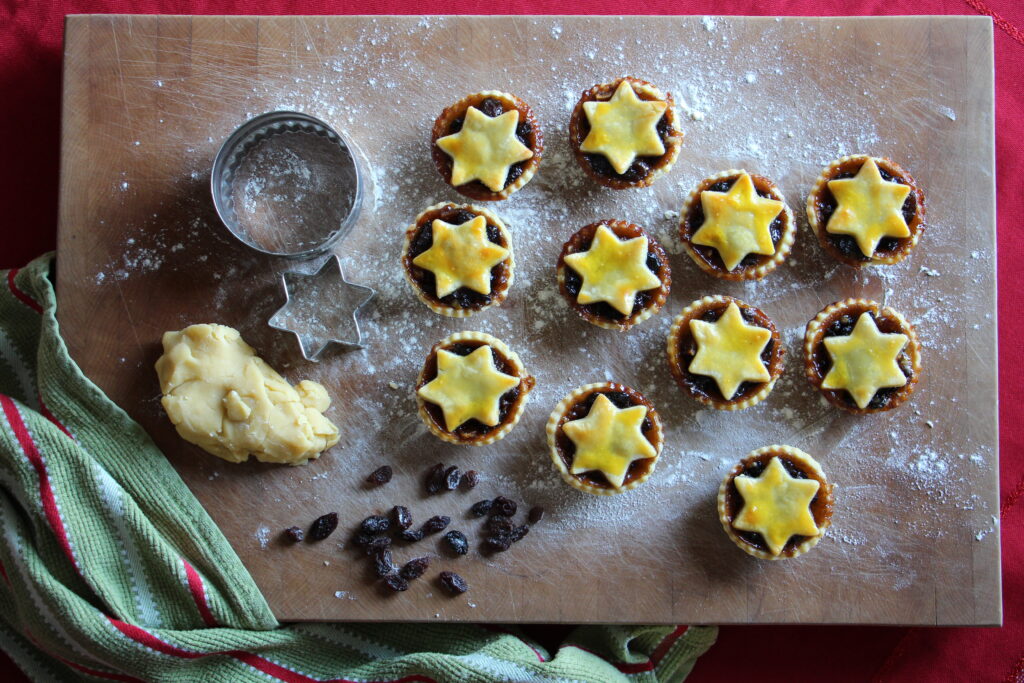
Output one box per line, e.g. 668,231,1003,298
57,16,1001,625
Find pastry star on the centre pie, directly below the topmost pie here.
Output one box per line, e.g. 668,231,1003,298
565,224,662,315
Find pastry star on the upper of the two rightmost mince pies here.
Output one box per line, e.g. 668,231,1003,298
825,159,910,257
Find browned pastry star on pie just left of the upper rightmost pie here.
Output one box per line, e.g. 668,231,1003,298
692,172,783,270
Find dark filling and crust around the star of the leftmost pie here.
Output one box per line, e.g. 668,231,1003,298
403,206,511,309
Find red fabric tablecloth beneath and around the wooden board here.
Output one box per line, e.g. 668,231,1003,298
0,0,1024,683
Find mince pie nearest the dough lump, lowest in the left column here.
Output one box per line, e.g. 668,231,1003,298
416,332,535,445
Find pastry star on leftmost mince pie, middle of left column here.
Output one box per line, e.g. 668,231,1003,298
413,216,509,299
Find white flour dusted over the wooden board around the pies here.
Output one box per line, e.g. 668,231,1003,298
95,16,995,618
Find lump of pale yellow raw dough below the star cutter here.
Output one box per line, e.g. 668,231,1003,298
156,324,338,465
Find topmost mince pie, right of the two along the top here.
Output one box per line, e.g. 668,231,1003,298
569,77,683,189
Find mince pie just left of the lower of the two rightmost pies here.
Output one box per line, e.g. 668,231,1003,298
668,296,784,411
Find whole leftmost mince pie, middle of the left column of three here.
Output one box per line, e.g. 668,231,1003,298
401,202,515,317
